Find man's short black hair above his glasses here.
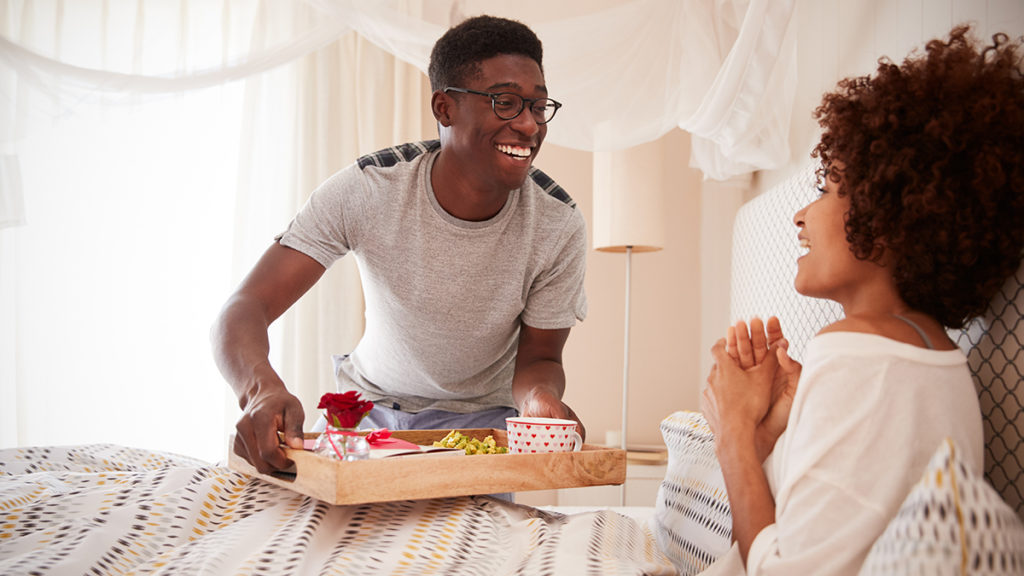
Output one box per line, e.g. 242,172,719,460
428,15,544,90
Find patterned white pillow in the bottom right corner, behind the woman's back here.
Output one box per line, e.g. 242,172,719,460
860,439,1024,576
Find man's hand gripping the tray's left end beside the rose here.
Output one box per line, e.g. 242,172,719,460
233,380,305,474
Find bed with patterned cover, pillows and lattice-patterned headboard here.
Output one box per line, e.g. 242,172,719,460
0,169,1024,576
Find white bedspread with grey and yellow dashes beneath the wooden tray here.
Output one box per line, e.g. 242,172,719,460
0,445,676,576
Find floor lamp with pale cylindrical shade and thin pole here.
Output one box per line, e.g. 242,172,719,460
593,145,665,505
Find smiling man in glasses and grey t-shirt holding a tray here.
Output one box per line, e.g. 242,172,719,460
212,16,586,472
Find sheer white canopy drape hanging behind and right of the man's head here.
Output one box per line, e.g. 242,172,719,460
299,0,797,179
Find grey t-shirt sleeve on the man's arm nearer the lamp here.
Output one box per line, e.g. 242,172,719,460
522,209,587,330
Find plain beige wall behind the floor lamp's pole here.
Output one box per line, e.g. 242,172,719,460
557,130,701,445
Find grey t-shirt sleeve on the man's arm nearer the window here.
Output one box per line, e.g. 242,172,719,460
274,164,362,268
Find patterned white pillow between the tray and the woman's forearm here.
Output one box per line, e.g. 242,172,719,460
654,411,732,576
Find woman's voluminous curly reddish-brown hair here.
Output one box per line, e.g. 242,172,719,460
812,26,1024,328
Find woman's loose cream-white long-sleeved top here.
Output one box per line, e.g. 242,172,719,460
705,332,984,576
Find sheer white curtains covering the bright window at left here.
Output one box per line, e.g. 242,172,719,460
0,0,424,460
